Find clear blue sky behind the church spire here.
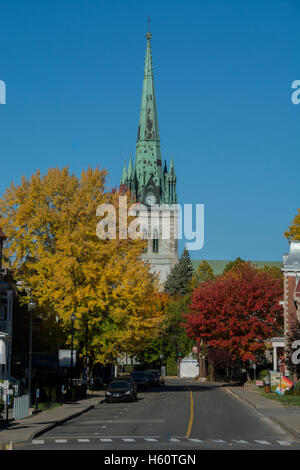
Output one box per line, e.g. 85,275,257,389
0,0,300,260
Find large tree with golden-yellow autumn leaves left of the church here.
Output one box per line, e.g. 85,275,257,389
0,167,164,363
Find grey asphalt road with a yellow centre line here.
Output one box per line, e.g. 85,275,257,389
20,379,300,451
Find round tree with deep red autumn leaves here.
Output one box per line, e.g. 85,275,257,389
185,263,283,362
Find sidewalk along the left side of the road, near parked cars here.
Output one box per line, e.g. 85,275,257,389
0,391,105,448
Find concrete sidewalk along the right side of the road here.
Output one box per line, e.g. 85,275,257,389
225,384,300,440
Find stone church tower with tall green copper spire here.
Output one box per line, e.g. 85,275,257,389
121,25,178,283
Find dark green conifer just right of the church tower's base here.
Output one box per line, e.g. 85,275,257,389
165,248,194,295
